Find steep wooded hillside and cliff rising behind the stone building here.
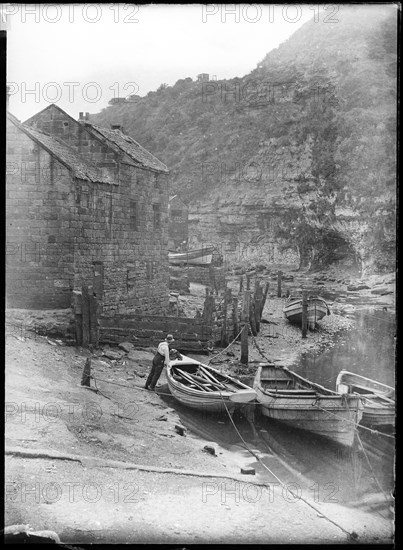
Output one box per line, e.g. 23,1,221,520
92,5,397,273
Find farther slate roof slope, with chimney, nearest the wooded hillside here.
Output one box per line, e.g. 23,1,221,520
85,122,168,174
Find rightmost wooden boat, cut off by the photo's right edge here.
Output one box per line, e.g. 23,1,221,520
336,370,396,426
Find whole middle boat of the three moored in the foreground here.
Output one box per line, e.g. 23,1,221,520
253,364,364,446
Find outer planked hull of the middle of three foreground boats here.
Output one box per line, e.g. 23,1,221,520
254,367,363,446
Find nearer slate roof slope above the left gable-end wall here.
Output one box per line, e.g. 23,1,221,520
9,114,114,183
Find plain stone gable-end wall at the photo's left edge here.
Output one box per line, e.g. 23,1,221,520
6,122,74,309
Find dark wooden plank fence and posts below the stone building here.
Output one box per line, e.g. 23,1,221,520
73,278,269,362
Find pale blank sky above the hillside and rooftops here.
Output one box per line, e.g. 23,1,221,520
1,4,316,121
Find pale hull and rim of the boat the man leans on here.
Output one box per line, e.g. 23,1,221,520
167,356,256,413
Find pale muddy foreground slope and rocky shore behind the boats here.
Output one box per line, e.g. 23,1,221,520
5,274,394,544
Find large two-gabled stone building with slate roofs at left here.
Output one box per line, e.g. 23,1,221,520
6,105,169,315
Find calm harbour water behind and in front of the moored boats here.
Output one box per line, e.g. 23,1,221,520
159,311,395,516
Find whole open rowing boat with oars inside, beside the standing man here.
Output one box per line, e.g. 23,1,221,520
167,355,256,413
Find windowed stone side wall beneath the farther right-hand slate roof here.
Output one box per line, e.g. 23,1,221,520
74,165,169,314
